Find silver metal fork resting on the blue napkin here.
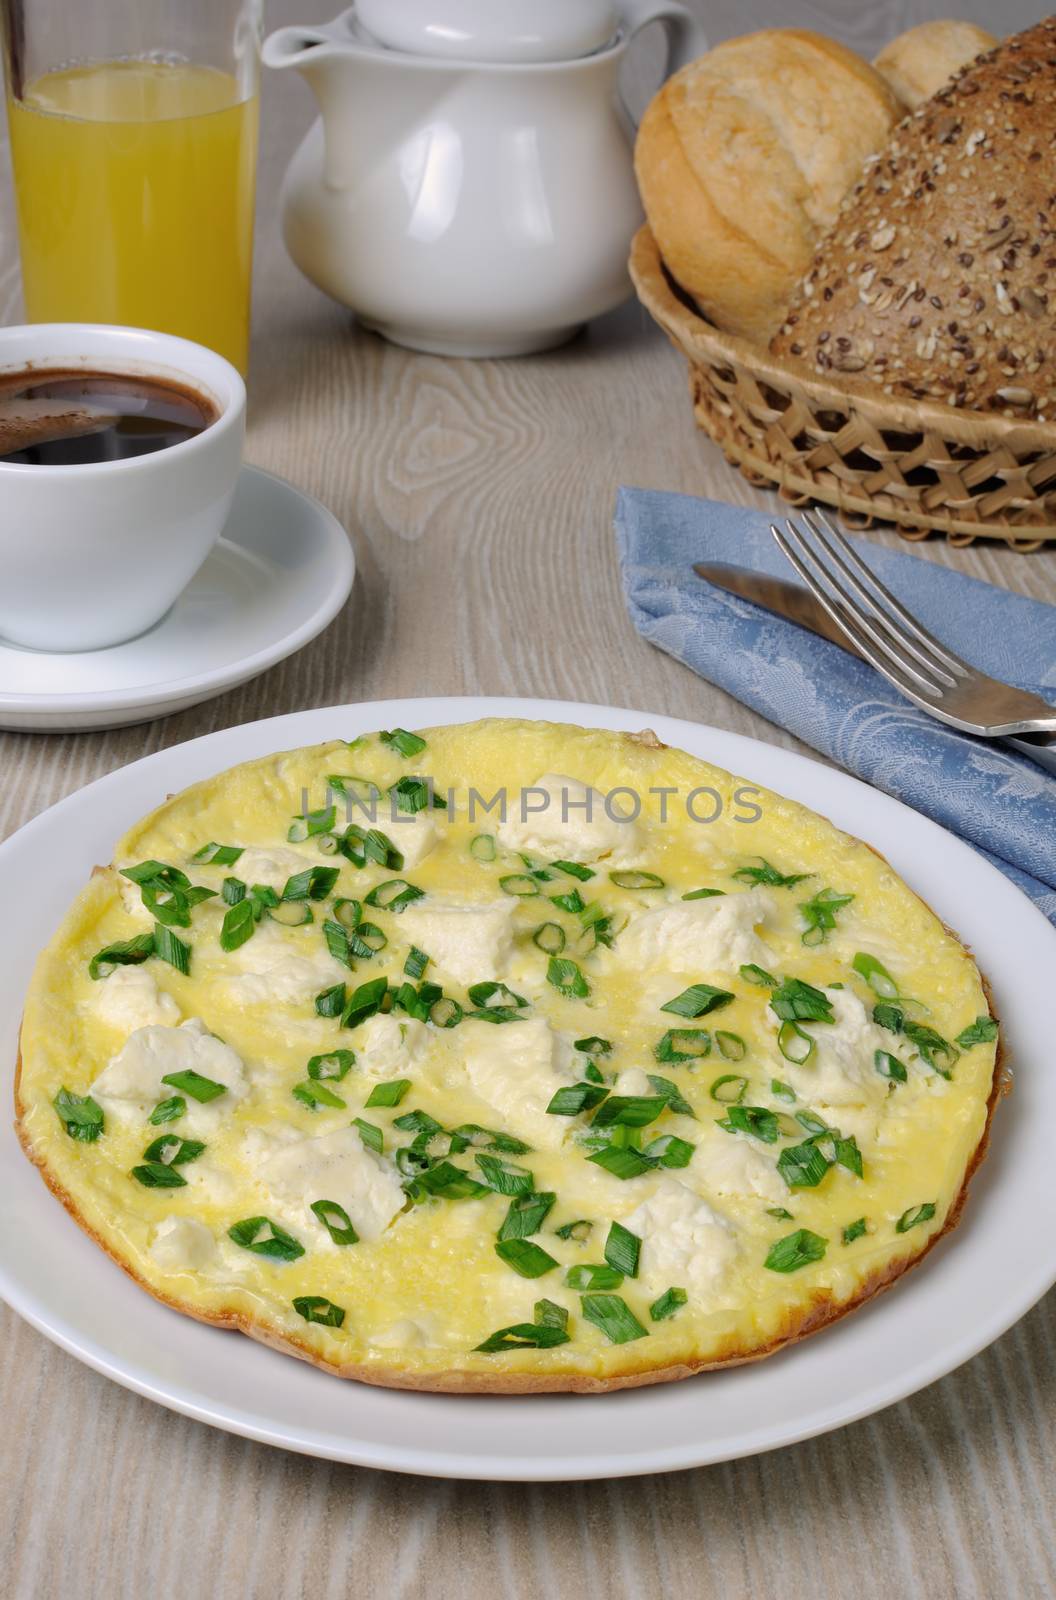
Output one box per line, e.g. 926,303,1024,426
770,512,1056,739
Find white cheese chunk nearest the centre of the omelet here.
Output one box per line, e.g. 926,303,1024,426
456,1018,574,1149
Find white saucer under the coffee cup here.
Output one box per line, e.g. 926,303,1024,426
0,467,355,733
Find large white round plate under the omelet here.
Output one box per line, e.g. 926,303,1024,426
0,699,1056,1480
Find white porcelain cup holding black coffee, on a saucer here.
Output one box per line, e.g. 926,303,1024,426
0,323,246,651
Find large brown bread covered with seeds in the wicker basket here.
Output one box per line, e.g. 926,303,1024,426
771,18,1056,421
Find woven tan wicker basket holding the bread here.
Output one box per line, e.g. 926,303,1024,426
630,226,1056,550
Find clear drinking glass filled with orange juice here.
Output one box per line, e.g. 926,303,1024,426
0,0,262,373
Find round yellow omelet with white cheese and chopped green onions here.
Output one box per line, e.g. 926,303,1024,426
16,718,1003,1394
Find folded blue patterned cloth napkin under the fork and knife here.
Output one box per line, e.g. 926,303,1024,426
616,488,1056,925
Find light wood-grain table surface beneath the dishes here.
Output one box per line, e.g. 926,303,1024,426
0,0,1056,1600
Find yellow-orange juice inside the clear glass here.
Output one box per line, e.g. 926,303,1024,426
8,61,258,371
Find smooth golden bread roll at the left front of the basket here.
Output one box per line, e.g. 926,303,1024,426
635,29,904,344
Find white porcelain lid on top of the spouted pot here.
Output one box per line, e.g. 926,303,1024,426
355,0,619,64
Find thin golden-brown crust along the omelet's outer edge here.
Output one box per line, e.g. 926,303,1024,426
14,731,1011,1395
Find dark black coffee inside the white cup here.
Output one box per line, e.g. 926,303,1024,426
0,366,218,467
